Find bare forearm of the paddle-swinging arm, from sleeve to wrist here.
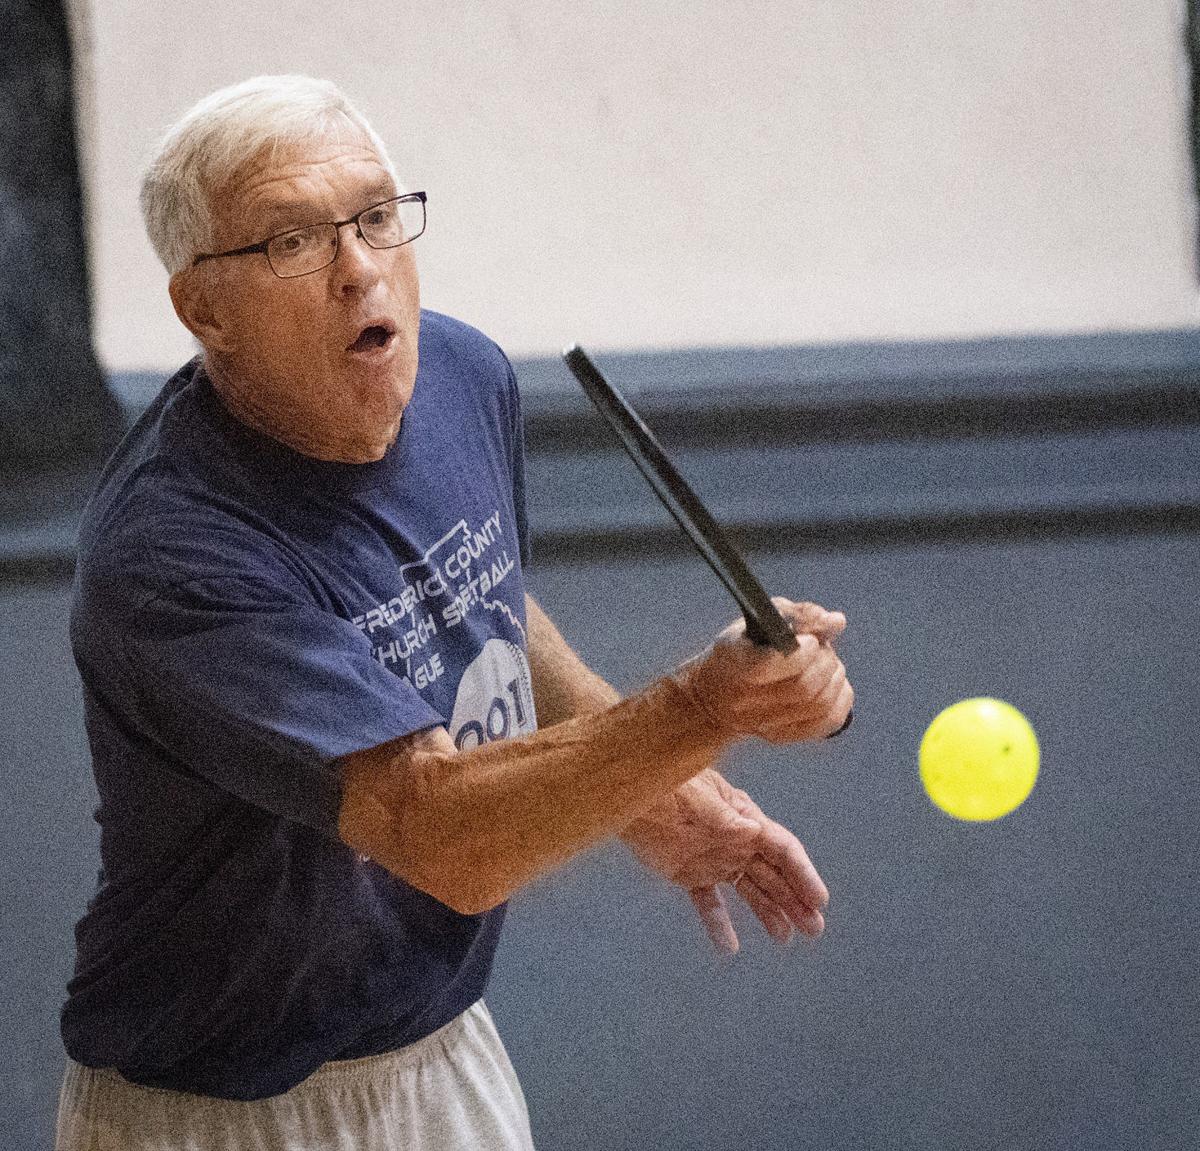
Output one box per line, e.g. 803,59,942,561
341,678,730,912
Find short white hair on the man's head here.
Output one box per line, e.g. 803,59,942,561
140,76,396,275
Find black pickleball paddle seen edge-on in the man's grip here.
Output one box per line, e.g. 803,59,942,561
563,344,853,735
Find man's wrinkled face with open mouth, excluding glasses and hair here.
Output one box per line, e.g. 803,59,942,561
184,134,420,463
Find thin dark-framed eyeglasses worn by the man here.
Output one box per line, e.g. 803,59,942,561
192,192,425,280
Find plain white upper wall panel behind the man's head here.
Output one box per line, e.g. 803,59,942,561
80,0,1196,371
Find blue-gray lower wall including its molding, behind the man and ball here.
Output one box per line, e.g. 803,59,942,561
0,332,1200,1151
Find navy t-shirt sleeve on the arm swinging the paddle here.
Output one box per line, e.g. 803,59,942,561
73,523,443,837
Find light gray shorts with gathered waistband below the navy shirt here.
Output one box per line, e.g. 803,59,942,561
55,1000,533,1151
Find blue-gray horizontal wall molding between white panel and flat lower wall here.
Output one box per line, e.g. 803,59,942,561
0,329,1200,581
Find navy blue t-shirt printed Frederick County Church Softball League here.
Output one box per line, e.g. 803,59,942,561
62,312,536,1099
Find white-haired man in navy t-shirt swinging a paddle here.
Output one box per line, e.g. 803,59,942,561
51,77,853,1151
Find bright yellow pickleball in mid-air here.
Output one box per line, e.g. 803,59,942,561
919,699,1039,821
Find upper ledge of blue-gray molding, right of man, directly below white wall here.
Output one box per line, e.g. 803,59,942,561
514,329,1200,442
